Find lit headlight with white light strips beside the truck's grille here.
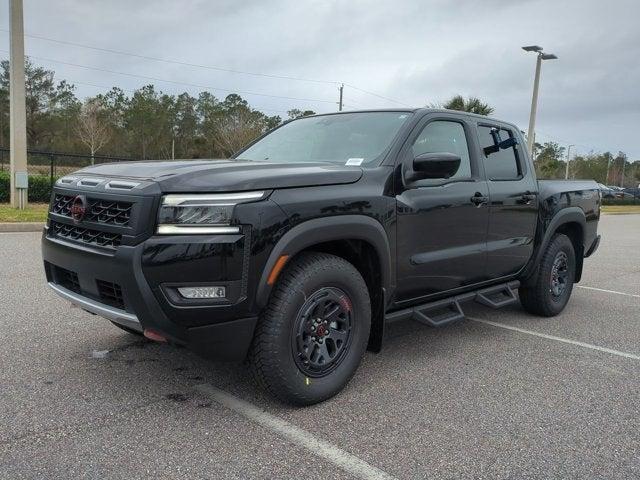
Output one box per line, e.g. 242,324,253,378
158,191,266,235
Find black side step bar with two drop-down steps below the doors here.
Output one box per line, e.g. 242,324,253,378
385,280,520,327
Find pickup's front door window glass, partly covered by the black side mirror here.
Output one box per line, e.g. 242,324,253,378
412,120,471,183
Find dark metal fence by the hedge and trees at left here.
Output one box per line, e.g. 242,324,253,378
0,148,137,184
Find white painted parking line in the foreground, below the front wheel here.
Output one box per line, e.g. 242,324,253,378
195,384,393,480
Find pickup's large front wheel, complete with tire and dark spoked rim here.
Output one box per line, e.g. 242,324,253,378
249,252,371,405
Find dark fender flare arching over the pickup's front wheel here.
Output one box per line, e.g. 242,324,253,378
256,215,395,308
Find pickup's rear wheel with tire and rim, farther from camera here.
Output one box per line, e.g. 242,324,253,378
519,234,576,317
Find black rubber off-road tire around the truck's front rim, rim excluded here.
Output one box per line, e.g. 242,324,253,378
248,252,371,405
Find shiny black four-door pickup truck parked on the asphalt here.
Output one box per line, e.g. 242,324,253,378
42,109,601,404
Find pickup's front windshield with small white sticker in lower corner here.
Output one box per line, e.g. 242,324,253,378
238,112,411,165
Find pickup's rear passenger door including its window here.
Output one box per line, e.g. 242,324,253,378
478,123,538,278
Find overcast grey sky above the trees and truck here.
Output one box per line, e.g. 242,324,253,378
0,0,640,160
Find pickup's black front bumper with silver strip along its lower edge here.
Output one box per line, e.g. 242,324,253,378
42,230,257,360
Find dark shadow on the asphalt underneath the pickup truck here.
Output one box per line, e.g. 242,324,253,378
82,307,521,410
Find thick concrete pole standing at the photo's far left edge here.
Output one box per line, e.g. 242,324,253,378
9,0,29,209
